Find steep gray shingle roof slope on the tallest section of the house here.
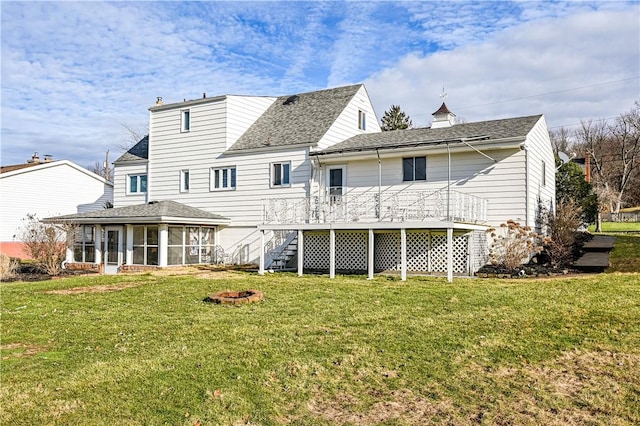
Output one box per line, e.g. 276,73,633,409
227,84,362,152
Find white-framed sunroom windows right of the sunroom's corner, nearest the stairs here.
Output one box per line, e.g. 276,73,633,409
167,226,215,265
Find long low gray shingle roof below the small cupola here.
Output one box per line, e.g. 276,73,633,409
319,115,542,154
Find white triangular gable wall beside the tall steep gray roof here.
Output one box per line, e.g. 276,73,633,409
318,86,380,149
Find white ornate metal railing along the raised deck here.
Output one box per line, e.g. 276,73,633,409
263,190,487,224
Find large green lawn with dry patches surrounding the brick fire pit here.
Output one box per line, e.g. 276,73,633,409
0,272,640,425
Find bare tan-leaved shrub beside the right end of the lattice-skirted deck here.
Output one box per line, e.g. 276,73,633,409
487,219,546,269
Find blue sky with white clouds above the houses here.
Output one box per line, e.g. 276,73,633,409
0,1,640,167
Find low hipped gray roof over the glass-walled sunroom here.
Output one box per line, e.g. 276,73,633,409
44,200,229,225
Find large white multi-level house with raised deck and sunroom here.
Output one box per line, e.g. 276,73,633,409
52,85,555,278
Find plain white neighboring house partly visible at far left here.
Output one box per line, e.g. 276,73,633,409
0,153,113,258
